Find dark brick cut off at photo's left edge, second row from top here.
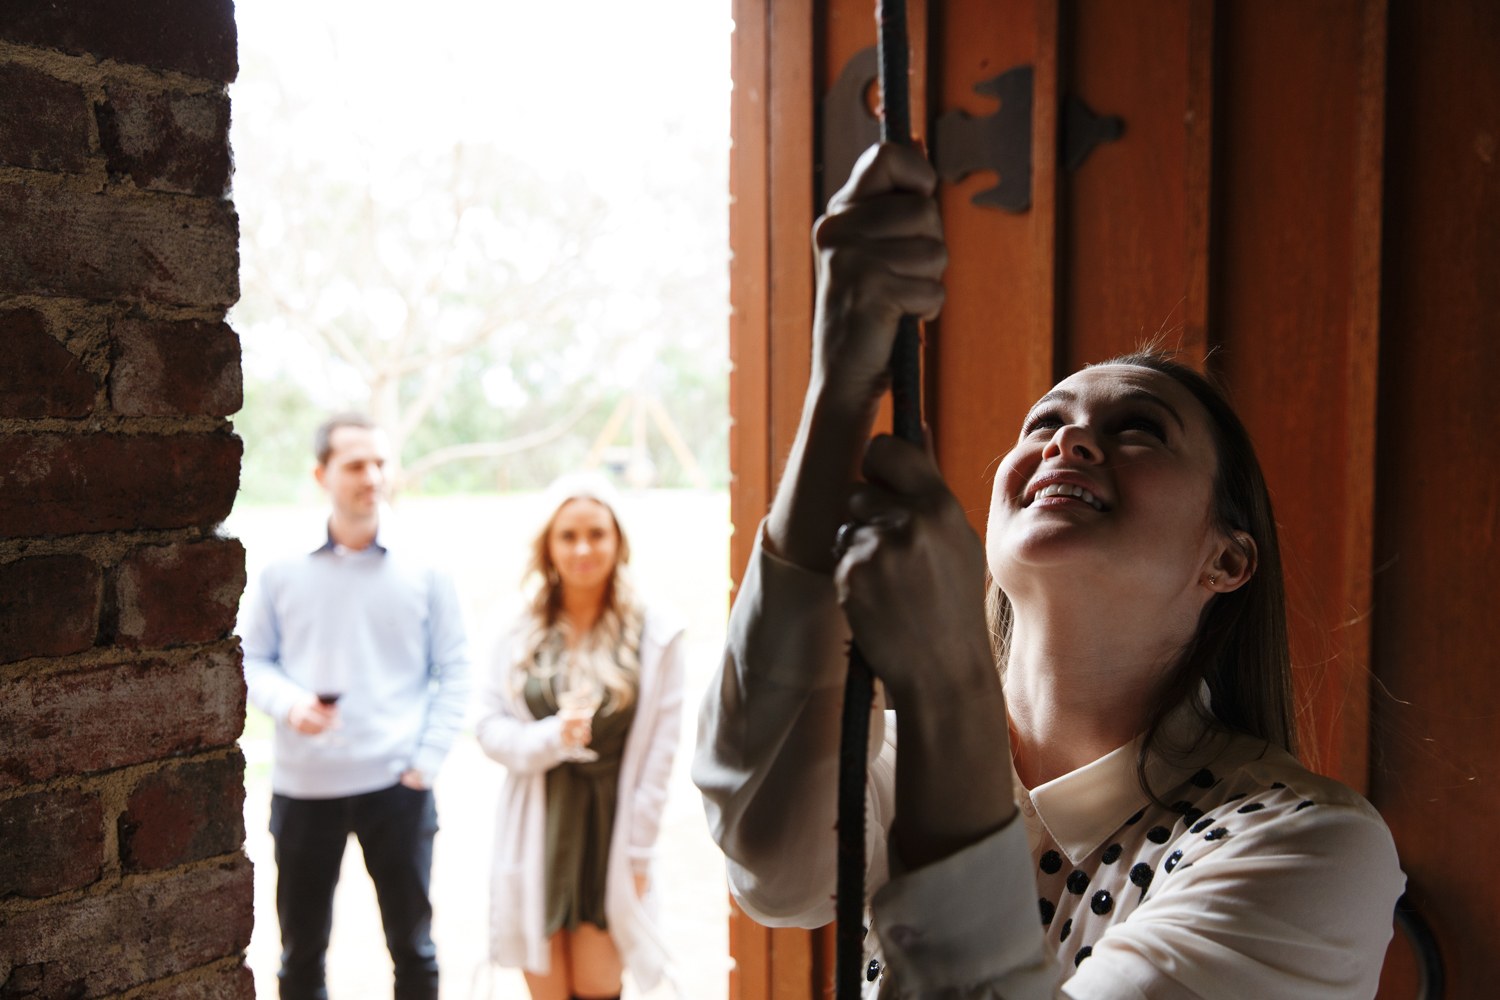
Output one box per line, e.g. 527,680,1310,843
0,62,89,174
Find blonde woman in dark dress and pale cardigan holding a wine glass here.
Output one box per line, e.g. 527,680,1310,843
477,474,683,1000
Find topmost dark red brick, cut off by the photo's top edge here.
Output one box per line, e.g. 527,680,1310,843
0,0,239,82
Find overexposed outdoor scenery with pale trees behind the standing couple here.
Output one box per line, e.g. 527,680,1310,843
227,0,731,1000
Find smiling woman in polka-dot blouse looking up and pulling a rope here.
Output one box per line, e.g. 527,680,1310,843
693,145,1404,1000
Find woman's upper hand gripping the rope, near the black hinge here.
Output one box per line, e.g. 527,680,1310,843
813,144,948,408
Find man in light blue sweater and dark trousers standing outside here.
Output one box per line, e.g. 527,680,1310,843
245,414,470,1000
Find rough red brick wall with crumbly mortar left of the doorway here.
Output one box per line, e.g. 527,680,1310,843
0,0,254,999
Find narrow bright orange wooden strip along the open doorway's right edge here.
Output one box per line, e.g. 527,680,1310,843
729,0,771,593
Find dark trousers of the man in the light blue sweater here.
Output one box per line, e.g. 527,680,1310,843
272,784,438,1000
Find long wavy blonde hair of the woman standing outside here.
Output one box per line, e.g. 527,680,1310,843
516,477,645,714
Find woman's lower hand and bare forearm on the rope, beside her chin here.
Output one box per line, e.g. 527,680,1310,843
834,436,1016,868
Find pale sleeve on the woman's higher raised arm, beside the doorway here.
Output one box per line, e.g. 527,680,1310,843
693,527,894,927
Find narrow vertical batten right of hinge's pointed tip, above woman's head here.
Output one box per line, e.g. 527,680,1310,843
1178,0,1215,370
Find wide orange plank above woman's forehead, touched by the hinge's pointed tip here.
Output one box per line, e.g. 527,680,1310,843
1058,0,1191,373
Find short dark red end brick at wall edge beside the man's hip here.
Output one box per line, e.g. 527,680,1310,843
119,753,245,871
